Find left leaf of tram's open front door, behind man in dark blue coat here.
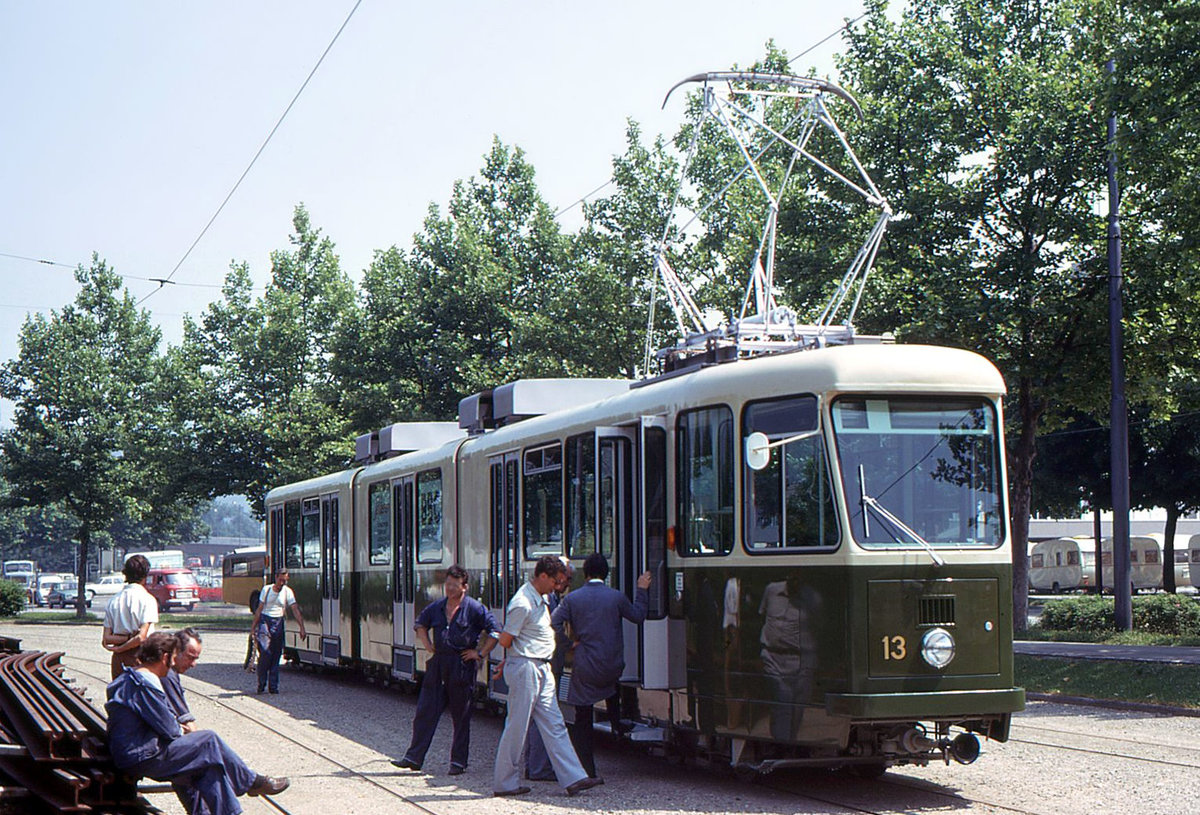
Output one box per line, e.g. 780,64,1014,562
595,426,644,682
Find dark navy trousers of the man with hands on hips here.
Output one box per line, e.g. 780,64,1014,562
404,651,479,767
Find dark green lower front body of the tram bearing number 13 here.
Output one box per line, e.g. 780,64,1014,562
671,563,1025,749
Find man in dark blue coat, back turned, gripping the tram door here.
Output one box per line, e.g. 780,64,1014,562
552,552,650,778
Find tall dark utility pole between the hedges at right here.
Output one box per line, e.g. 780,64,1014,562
1105,60,1133,631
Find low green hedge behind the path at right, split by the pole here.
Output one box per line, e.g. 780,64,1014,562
1038,594,1200,636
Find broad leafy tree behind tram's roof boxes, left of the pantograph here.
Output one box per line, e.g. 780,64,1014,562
336,140,587,424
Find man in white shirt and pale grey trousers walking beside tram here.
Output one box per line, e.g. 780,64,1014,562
492,555,604,796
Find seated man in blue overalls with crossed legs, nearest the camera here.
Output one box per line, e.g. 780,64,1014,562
104,631,289,815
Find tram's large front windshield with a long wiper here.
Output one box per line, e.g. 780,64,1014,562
833,396,1004,549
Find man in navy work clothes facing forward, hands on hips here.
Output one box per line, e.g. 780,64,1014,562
391,565,498,775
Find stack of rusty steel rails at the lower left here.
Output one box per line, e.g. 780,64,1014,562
0,637,158,815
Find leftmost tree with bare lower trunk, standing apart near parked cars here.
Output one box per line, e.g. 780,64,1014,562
0,256,169,616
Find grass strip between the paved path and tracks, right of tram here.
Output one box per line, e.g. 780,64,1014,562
1014,654,1200,708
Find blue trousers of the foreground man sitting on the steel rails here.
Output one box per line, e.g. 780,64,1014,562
128,730,254,815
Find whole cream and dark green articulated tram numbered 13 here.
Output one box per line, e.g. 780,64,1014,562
266,344,1024,772
